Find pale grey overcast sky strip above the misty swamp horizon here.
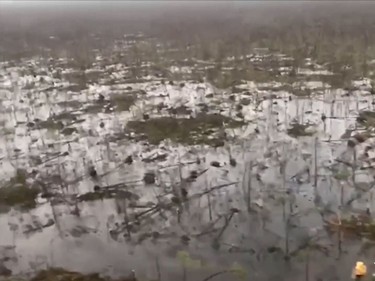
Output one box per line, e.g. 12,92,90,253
0,0,375,29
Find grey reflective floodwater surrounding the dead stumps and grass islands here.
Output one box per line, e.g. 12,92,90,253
0,57,374,280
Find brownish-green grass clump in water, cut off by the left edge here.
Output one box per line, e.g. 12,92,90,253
0,170,40,209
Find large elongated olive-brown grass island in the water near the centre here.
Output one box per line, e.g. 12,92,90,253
127,113,244,146
